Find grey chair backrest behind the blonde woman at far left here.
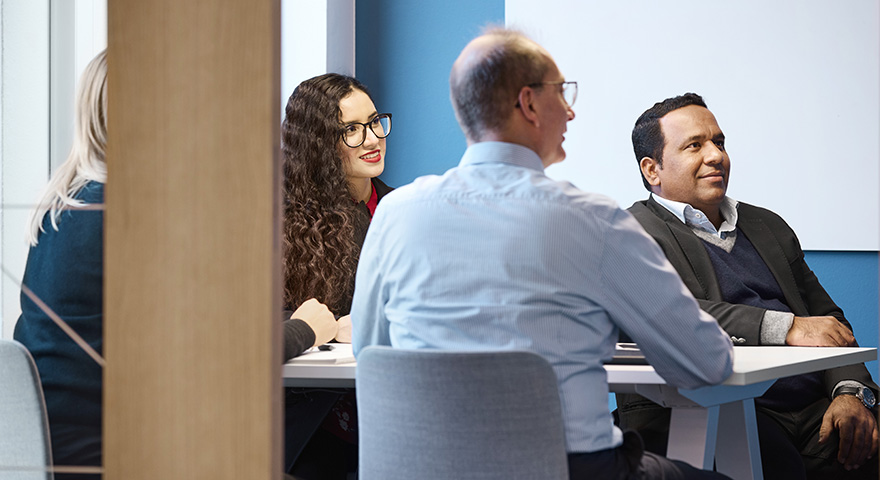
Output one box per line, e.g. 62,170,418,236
0,339,53,480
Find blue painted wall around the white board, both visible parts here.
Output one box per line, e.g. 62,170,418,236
356,0,880,379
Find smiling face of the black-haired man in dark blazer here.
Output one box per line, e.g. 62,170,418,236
640,105,730,218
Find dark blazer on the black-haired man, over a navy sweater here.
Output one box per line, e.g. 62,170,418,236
628,193,878,397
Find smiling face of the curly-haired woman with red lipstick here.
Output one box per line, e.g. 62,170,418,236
338,89,385,199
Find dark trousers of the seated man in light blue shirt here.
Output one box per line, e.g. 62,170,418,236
568,432,728,480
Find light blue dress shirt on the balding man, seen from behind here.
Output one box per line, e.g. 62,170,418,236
351,142,733,452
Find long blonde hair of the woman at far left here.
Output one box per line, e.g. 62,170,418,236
27,50,107,246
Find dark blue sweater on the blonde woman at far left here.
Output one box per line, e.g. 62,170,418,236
14,182,104,479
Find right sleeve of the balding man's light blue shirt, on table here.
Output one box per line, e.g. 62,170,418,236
600,210,733,388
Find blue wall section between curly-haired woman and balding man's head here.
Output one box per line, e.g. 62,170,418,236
355,0,504,186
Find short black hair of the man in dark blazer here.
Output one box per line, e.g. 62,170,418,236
632,93,709,192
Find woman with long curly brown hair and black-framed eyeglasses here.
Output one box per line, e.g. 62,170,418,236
281,73,391,479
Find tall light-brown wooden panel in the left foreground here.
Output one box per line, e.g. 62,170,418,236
104,0,282,480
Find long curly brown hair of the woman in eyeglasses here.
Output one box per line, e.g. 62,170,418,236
281,73,372,315
